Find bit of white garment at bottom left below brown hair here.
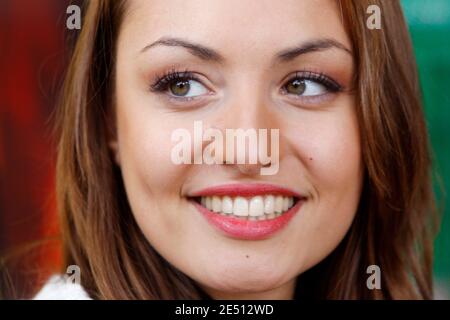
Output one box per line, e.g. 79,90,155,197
33,275,92,300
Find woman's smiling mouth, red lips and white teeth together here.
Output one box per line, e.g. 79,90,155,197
189,184,306,240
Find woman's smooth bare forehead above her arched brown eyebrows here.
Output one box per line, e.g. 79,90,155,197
119,0,351,61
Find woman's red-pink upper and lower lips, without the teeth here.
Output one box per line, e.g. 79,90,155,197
192,184,306,240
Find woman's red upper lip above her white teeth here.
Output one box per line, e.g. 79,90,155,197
189,183,306,198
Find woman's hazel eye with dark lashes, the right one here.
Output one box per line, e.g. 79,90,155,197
283,72,341,97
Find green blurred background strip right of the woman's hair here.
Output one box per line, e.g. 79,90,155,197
401,0,450,298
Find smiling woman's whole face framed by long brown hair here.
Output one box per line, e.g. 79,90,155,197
112,0,363,298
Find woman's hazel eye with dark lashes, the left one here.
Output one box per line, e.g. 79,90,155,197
151,71,208,98
